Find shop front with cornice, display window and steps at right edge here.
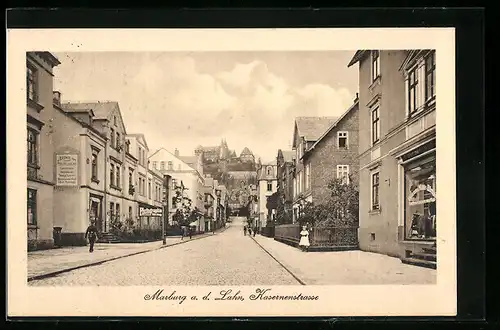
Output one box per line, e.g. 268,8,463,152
398,138,437,268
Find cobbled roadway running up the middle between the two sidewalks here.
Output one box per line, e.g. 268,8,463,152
29,218,300,286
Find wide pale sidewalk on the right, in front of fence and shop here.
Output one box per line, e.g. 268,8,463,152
253,235,437,285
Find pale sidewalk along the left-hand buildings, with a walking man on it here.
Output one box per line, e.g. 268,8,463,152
28,227,227,281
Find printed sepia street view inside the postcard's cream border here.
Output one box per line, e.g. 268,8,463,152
26,50,438,286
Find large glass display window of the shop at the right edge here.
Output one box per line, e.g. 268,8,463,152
405,159,436,240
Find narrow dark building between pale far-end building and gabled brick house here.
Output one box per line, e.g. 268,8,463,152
276,149,295,224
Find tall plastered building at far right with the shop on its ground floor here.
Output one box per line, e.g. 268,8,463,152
349,50,436,267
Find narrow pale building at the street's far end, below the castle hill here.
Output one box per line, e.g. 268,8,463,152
257,162,278,227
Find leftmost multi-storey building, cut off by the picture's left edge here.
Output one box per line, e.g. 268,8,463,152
26,52,61,250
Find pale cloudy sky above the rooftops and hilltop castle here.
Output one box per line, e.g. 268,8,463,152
54,51,358,161
